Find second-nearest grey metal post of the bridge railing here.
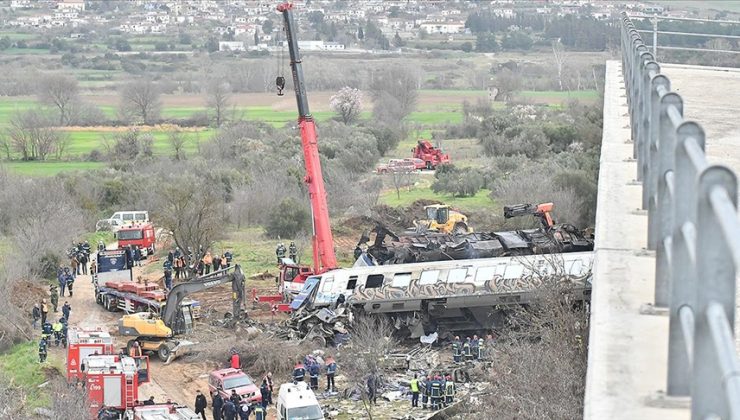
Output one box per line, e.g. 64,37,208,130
668,120,704,396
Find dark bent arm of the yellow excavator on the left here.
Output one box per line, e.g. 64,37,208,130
161,264,245,328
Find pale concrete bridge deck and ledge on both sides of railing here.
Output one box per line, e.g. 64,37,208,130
584,61,740,420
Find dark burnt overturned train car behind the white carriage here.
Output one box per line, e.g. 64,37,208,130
366,225,594,265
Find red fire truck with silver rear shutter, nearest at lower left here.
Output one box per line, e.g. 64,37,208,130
80,354,149,418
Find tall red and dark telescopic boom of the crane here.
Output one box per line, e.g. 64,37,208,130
277,3,337,274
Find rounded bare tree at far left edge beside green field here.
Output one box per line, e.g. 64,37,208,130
7,109,63,160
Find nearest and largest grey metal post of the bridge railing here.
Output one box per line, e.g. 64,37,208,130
691,165,737,419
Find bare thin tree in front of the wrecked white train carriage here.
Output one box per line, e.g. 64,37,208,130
340,315,397,420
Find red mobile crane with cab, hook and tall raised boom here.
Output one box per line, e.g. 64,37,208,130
252,3,337,311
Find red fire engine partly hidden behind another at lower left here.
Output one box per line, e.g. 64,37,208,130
67,327,116,382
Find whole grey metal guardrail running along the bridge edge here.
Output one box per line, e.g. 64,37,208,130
622,14,740,419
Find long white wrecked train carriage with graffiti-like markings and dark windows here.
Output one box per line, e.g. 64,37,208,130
291,252,593,338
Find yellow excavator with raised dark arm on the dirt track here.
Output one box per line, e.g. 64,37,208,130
118,264,245,363
